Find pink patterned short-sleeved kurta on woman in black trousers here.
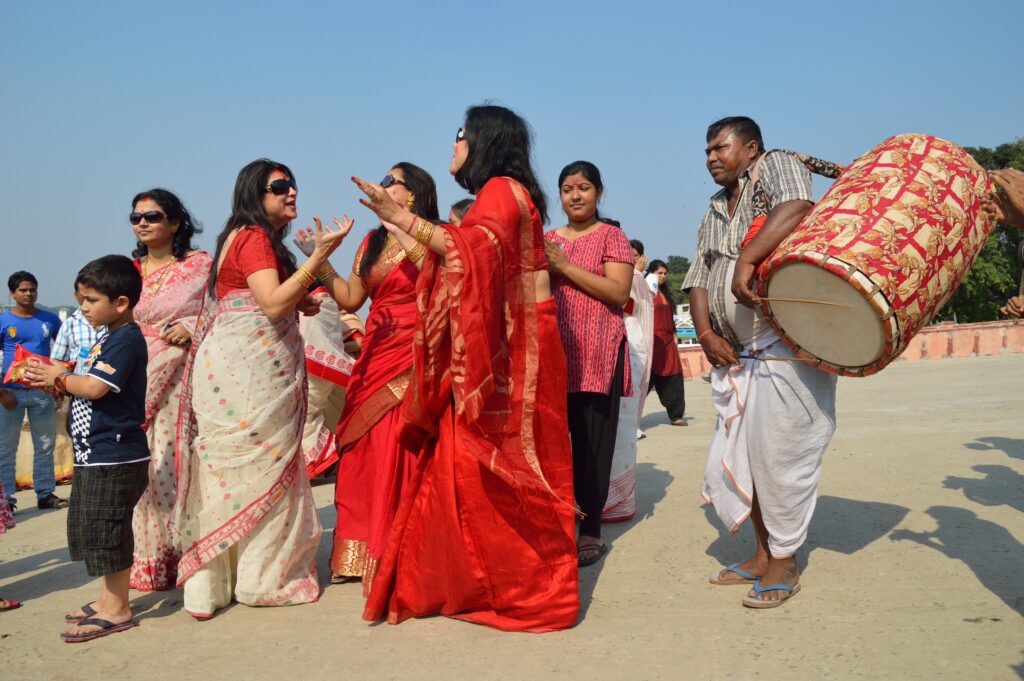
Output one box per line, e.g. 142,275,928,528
544,224,633,396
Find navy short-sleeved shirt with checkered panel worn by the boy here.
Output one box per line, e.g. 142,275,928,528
71,323,150,466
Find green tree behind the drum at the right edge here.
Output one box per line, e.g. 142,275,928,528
935,138,1024,323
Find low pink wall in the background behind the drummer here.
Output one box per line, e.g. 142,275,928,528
679,322,1024,381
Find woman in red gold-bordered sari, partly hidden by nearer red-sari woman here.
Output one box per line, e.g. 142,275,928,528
296,162,438,594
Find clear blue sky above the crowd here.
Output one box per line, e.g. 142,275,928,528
0,0,1024,305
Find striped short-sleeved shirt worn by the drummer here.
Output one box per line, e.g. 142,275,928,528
682,154,811,349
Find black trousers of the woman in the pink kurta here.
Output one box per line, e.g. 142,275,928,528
568,343,626,537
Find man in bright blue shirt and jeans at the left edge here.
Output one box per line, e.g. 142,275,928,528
0,271,68,510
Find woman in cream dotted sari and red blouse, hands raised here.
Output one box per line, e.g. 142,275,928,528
174,159,352,620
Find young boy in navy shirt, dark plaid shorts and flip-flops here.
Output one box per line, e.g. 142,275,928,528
26,255,150,643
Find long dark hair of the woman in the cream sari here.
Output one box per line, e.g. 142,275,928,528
210,159,296,296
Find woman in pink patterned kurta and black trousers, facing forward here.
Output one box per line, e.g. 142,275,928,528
545,161,633,567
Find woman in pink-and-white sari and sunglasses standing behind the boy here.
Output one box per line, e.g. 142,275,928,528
128,188,213,591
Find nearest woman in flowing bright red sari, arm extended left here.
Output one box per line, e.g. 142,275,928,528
353,105,580,632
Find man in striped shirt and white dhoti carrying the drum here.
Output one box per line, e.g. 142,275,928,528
683,117,836,608
